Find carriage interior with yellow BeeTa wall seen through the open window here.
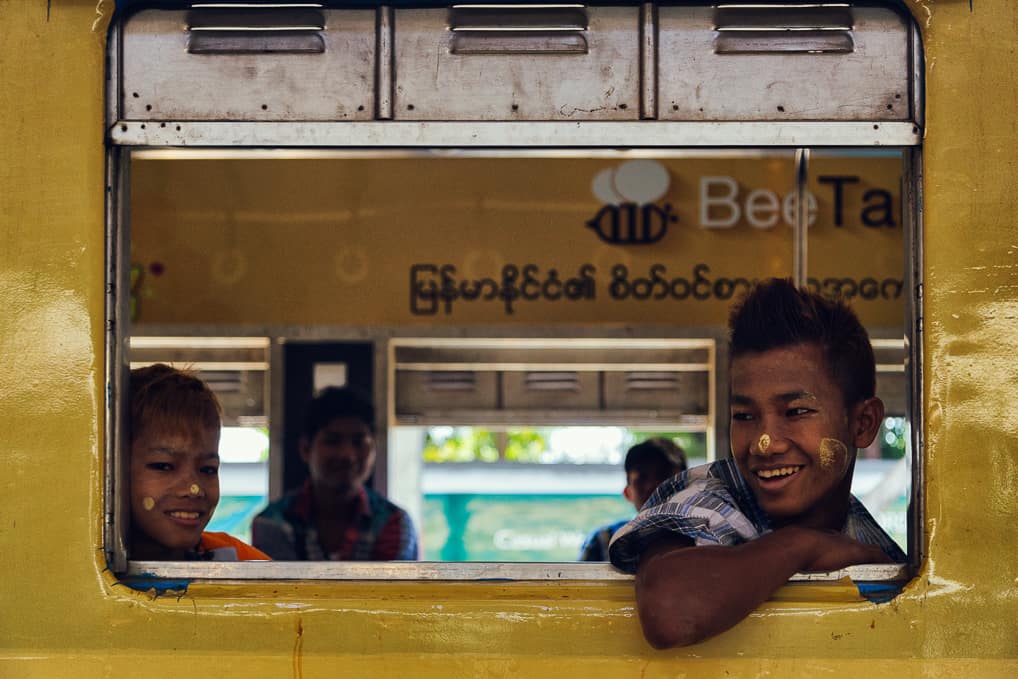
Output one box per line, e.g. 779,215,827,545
119,150,911,561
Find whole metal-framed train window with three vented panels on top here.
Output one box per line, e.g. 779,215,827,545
106,3,921,580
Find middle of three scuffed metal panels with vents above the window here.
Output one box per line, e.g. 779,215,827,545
395,7,640,120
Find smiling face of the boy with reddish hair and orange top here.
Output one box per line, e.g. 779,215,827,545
130,428,219,560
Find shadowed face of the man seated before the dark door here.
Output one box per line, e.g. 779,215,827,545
300,416,375,492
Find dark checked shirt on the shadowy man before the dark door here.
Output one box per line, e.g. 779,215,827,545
251,483,418,561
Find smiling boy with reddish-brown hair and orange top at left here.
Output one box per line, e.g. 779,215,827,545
128,363,269,561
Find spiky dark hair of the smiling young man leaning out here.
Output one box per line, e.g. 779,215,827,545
729,278,876,405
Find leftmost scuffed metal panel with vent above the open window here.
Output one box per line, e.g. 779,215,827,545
121,9,376,122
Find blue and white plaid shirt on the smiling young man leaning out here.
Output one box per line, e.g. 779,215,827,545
609,459,906,573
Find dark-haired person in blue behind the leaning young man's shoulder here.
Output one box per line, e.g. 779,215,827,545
579,438,686,561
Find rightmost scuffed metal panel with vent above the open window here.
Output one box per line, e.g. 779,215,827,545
658,5,910,121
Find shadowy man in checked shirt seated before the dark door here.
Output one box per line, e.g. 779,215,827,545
251,387,417,561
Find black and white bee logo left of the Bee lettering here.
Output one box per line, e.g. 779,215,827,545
586,160,679,245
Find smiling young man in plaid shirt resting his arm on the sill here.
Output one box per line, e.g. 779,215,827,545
609,280,905,648
